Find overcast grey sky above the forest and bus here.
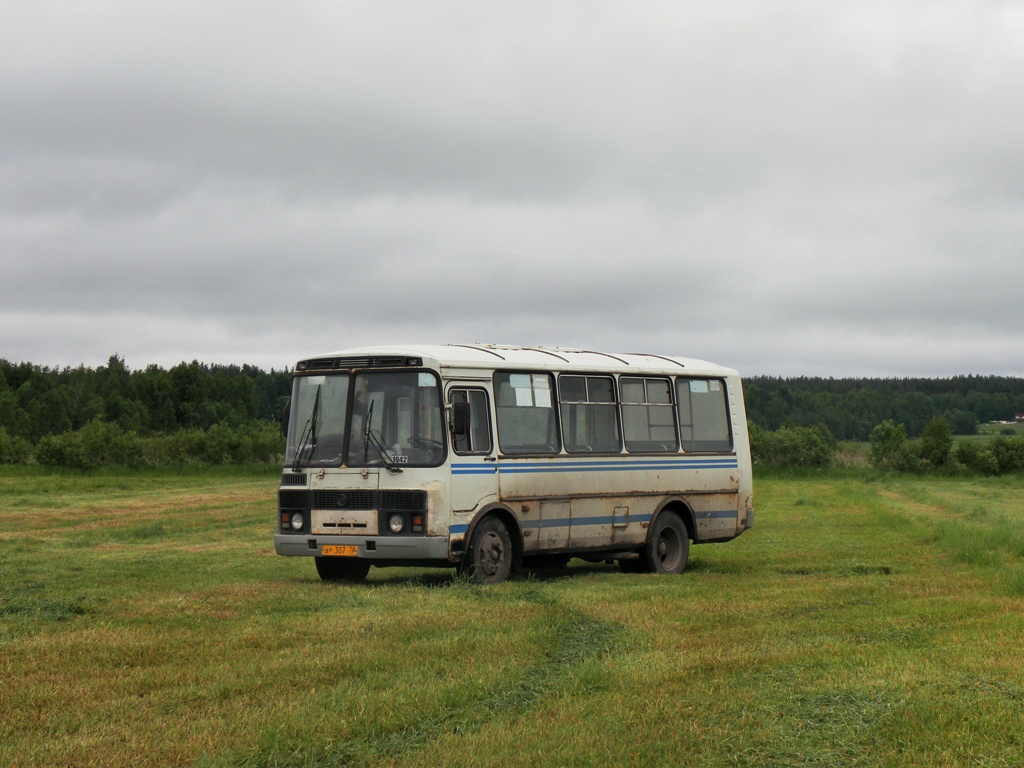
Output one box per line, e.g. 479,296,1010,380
0,0,1024,377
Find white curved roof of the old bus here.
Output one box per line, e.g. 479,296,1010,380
297,344,738,376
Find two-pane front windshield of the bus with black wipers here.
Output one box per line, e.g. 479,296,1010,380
285,371,444,472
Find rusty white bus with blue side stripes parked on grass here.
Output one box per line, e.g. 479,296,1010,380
273,344,754,583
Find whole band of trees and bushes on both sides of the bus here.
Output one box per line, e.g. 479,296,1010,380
0,354,1024,469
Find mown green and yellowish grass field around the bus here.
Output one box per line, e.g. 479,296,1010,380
0,468,1024,767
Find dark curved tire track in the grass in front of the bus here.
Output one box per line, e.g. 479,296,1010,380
228,596,624,768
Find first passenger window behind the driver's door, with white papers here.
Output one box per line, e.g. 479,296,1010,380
494,372,558,454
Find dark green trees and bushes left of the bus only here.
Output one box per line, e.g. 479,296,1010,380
0,354,292,467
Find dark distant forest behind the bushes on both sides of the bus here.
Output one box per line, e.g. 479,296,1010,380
0,355,1024,444
